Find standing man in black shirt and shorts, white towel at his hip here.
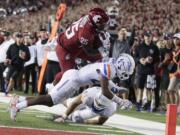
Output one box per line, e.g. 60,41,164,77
135,31,159,111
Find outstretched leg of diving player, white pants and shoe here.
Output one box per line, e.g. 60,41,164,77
10,70,79,120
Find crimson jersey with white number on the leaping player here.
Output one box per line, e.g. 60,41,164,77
58,15,102,56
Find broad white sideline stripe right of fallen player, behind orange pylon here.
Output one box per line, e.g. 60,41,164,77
105,114,180,135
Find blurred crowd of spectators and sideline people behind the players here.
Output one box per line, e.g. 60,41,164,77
0,0,180,112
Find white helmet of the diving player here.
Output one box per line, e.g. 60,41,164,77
115,53,135,80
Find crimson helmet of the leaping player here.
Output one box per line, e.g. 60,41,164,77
88,8,109,30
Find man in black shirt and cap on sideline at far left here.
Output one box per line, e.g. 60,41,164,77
4,33,30,94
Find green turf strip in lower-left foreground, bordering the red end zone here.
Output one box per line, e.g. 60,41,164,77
0,104,139,135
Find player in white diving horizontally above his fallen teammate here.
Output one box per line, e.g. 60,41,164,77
10,54,135,120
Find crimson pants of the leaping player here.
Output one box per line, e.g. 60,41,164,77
55,45,101,82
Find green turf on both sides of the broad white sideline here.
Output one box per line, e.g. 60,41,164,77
0,92,180,135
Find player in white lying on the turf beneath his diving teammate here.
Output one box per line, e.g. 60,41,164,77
54,87,132,125
